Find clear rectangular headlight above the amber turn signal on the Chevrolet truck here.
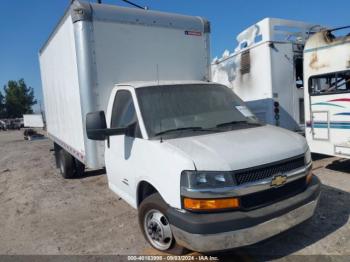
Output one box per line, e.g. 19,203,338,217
181,171,235,189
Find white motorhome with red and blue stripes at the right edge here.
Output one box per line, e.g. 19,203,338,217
304,30,350,158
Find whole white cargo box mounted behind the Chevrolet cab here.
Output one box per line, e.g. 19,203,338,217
39,1,210,171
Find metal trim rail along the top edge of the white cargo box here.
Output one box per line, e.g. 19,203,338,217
39,0,210,54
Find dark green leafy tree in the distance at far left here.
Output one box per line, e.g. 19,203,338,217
4,79,37,118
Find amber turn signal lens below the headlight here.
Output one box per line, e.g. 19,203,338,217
184,198,239,211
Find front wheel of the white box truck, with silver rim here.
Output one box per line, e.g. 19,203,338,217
138,193,189,255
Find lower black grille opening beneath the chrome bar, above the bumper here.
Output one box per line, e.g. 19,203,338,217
240,177,307,210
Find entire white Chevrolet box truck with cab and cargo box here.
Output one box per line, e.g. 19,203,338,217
40,1,320,254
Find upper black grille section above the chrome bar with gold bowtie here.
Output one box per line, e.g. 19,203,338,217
235,155,305,185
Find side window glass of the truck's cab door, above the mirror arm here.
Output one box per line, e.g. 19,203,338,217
111,90,142,138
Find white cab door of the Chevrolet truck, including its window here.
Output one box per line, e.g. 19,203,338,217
105,89,142,205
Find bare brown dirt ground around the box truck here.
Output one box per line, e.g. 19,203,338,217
0,131,350,261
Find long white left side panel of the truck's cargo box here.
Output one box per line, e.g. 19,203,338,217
40,16,85,161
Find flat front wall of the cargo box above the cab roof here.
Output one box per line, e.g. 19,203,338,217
93,21,209,110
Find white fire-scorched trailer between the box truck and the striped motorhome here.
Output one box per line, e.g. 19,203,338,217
212,18,321,131
